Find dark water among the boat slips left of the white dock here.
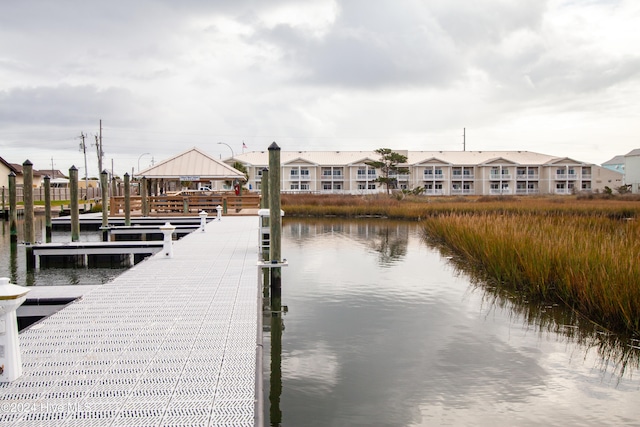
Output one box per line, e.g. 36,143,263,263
0,215,126,286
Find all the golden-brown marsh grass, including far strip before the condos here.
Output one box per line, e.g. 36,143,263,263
282,195,640,334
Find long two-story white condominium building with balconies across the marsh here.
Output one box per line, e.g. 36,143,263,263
226,150,623,196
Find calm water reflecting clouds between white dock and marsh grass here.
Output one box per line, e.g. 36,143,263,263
264,219,640,427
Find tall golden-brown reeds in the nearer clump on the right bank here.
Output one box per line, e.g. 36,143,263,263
423,213,640,334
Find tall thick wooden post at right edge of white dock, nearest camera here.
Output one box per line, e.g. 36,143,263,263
269,142,282,290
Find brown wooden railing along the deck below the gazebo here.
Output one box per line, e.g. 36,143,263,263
109,194,260,216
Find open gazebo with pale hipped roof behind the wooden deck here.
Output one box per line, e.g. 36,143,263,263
136,147,246,194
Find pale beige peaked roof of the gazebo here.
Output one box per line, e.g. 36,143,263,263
137,147,244,179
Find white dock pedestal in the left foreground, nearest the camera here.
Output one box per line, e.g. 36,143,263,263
0,277,29,383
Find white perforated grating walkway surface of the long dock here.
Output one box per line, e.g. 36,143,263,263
0,216,259,427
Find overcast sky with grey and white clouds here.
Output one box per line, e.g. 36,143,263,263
0,0,640,177
